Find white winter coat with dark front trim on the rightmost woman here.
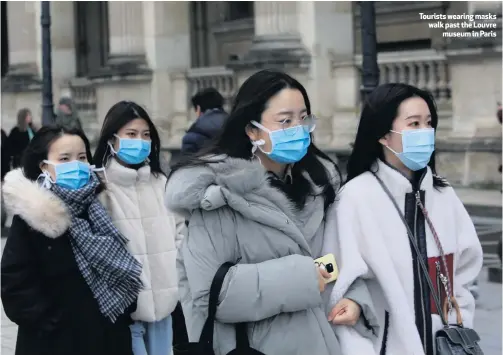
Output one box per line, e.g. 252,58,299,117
336,161,482,355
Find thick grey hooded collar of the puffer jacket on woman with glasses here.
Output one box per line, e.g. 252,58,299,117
165,156,337,253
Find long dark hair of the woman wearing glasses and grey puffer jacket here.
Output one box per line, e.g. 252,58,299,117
170,70,340,209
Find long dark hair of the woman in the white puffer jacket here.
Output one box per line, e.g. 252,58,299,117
94,101,164,176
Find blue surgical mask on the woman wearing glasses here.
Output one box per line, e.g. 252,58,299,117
251,121,314,164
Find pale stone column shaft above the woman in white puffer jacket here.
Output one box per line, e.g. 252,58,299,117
108,1,146,70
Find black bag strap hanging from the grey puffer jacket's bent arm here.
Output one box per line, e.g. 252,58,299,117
199,262,249,351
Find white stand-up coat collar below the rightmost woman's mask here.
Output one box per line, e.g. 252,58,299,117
372,159,433,201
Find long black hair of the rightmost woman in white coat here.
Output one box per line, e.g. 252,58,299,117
346,84,447,188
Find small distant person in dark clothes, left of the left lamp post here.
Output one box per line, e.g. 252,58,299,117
7,108,36,169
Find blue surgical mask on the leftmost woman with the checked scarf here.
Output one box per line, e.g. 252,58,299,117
43,160,91,190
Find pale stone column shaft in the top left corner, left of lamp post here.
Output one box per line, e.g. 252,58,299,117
7,1,41,79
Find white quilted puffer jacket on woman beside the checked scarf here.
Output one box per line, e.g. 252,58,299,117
100,159,185,322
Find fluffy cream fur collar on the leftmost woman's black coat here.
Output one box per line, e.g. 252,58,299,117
2,169,71,238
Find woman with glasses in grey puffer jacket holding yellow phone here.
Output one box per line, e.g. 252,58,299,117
166,71,376,355
